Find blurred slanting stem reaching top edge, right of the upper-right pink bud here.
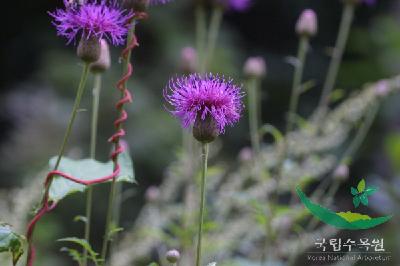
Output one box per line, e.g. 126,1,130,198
318,3,355,116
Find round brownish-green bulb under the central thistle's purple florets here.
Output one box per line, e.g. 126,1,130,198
193,115,219,143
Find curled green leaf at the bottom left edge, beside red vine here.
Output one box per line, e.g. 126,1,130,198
0,223,25,265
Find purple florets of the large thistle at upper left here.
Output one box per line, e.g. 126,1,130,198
49,0,133,45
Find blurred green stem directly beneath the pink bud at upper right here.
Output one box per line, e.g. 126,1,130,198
286,36,309,134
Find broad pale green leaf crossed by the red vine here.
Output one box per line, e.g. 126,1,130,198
49,152,136,202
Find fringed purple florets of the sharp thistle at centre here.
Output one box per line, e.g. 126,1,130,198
164,74,243,133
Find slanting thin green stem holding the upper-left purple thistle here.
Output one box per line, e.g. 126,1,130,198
44,63,90,199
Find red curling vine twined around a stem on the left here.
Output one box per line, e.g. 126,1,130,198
26,29,141,266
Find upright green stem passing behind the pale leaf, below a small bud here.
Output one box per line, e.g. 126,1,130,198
83,73,101,266
